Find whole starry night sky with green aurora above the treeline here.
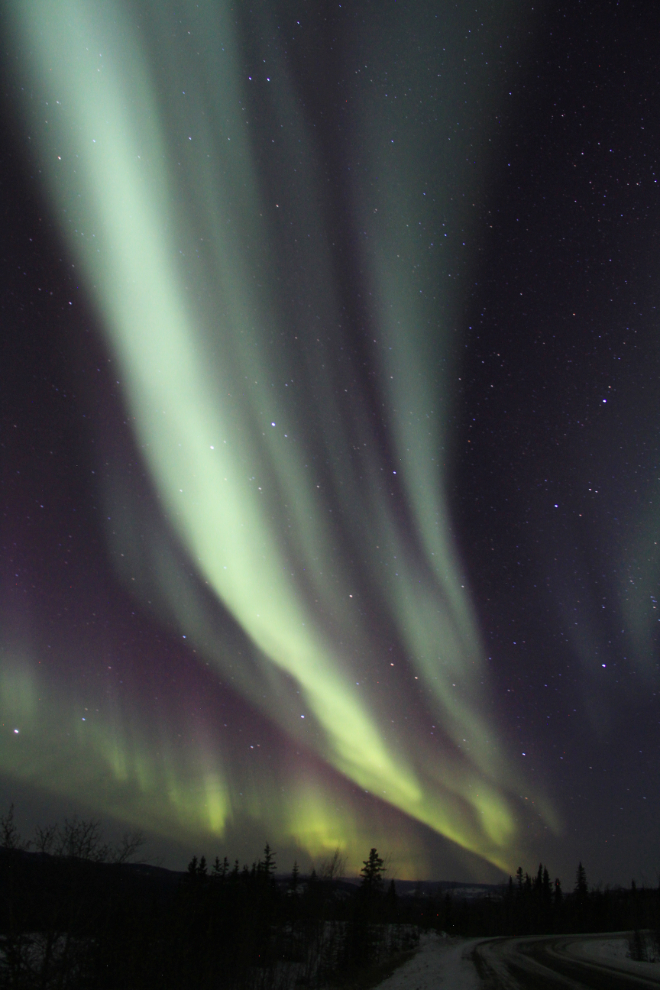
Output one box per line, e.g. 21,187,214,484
0,0,660,887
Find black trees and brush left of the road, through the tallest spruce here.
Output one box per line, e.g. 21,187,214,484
0,812,419,990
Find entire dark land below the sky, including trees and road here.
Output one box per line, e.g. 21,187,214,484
0,848,660,990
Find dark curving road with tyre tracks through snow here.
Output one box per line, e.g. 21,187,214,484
473,932,660,990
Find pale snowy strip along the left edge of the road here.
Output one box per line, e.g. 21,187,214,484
377,932,483,990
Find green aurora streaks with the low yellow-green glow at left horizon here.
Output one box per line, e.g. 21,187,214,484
1,0,552,880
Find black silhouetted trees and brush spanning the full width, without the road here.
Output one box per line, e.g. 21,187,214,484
0,811,660,990
